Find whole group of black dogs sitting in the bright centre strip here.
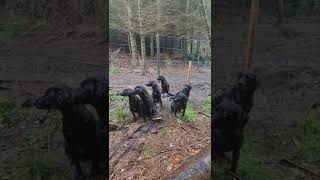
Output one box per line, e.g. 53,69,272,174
120,76,192,131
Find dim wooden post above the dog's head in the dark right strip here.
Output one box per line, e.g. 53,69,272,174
245,0,259,72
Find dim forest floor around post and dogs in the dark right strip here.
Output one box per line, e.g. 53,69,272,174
213,9,320,180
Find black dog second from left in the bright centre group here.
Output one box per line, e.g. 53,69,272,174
133,86,156,120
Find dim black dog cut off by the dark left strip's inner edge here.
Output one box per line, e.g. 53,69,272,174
75,77,108,128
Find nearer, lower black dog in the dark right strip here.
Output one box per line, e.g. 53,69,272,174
213,99,248,173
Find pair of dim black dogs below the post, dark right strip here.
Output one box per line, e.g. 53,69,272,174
213,73,259,173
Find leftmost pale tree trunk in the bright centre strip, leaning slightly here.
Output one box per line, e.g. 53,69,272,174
127,0,139,66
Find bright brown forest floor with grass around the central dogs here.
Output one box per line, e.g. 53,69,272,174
109,62,211,179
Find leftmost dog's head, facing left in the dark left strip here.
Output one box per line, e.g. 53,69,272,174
34,85,73,109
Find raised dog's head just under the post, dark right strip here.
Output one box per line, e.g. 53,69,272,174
237,73,259,92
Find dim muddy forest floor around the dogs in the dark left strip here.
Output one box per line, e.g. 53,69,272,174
0,16,107,180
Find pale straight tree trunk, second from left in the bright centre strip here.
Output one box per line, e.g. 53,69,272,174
138,0,147,75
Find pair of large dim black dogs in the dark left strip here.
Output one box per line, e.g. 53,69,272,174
33,77,108,179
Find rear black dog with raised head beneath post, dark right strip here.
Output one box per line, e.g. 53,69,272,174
213,73,259,113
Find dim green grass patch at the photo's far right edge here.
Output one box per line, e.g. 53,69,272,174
297,108,320,162
